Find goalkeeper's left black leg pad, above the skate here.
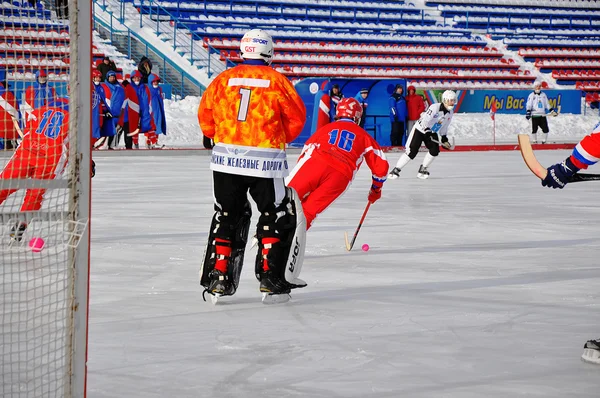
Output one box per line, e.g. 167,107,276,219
200,202,252,295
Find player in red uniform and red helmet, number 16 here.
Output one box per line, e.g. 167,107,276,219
286,97,389,229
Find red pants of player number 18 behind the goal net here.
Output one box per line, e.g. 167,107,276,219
0,150,59,211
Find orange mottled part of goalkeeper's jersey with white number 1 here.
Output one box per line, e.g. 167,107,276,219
198,64,306,150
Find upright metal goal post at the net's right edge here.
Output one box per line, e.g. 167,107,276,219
65,0,92,397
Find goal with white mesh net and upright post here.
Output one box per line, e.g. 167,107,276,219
0,0,92,398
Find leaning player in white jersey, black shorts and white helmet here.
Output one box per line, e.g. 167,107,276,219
388,90,456,180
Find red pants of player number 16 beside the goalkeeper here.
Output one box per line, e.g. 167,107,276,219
287,155,352,230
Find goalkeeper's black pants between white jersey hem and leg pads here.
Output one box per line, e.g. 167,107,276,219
213,171,285,240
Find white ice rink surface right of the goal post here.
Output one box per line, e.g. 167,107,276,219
87,151,600,398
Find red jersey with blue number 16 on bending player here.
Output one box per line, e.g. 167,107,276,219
300,119,389,182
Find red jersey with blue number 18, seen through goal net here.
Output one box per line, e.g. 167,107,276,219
19,106,69,160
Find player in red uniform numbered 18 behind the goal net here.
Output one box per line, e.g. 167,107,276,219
0,101,69,239
